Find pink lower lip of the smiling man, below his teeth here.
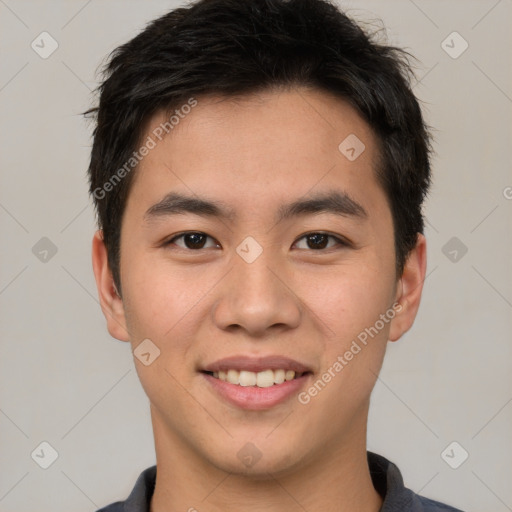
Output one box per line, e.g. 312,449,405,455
202,373,311,411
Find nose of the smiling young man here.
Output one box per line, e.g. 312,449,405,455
212,247,301,337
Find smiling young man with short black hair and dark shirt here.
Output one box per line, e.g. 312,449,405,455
89,0,464,512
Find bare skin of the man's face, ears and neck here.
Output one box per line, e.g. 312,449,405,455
92,89,426,512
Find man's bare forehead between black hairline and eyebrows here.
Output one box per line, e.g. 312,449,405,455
129,89,385,222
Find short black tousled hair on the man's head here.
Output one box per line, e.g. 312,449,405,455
84,0,431,294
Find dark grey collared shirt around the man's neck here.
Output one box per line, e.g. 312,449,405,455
97,452,462,512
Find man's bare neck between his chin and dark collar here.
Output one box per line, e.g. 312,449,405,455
150,409,382,512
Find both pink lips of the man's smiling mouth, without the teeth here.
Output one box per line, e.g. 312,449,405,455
200,355,313,411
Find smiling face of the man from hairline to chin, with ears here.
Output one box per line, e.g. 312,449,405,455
93,90,425,475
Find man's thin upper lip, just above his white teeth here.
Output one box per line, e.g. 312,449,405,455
203,355,311,373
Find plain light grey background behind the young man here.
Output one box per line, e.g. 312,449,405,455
0,0,512,512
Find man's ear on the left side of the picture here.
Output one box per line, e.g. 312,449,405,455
92,230,130,341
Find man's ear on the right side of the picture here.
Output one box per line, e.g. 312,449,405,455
389,233,427,341
